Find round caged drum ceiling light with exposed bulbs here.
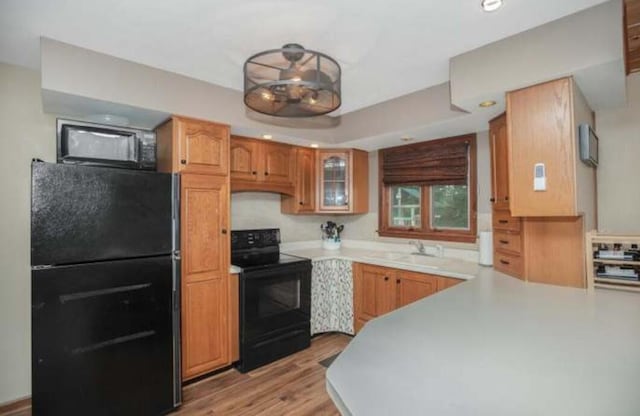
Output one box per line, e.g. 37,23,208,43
244,43,342,117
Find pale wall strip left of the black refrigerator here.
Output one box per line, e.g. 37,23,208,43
0,63,56,403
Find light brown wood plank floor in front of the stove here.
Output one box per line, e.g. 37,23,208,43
0,334,351,416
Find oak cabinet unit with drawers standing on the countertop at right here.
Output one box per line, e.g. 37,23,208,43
489,77,596,287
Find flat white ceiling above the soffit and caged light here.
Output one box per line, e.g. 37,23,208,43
0,0,604,115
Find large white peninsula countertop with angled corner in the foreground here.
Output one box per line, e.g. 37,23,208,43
327,267,640,416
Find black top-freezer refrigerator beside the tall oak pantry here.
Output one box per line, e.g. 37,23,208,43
31,161,181,415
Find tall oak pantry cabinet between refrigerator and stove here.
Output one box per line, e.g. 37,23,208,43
156,116,235,380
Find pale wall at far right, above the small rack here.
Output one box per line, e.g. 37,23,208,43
596,73,640,234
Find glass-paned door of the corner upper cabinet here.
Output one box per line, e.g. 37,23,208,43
319,152,351,211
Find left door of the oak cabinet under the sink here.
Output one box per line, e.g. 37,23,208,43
354,264,396,331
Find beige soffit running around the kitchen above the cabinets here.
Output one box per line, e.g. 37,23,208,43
41,2,626,150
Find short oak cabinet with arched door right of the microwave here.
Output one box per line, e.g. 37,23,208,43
156,116,229,175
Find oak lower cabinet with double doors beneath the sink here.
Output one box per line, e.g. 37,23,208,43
353,263,463,332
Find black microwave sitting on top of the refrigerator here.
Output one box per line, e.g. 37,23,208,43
57,119,156,170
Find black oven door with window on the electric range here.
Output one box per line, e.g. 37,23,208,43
240,262,311,345
